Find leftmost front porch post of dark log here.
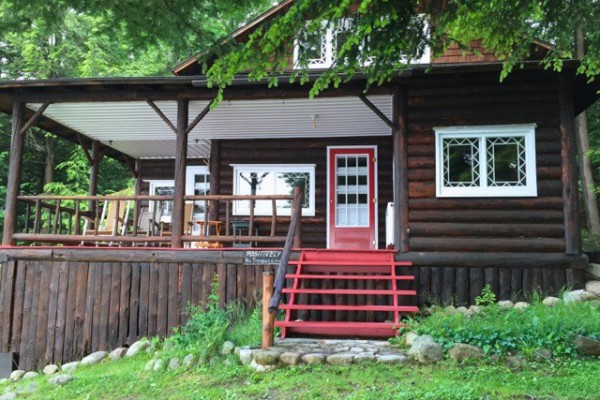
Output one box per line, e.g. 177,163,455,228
2,103,25,245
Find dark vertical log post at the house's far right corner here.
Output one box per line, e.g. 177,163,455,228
558,73,581,255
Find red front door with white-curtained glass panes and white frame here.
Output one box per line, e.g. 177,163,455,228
327,147,377,250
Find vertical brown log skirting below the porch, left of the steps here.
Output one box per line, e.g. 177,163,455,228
0,259,271,371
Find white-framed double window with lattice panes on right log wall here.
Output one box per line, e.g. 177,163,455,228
435,124,537,197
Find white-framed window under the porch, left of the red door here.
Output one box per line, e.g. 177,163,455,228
232,164,315,216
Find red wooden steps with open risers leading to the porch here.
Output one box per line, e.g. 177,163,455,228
275,250,418,338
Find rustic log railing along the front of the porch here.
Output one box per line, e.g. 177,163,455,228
13,192,301,247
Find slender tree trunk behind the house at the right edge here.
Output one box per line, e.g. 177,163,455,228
575,28,600,235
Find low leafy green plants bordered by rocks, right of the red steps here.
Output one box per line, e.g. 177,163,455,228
404,302,600,356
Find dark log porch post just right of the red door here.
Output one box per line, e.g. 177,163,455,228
386,88,410,253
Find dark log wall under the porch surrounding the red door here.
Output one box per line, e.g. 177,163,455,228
220,139,393,248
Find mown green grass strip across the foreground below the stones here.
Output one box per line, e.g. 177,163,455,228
0,356,600,400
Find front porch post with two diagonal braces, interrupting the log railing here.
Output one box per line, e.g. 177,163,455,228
171,99,189,247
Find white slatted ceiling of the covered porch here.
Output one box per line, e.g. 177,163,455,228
28,95,392,158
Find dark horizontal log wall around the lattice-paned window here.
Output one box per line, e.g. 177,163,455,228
408,73,565,253
